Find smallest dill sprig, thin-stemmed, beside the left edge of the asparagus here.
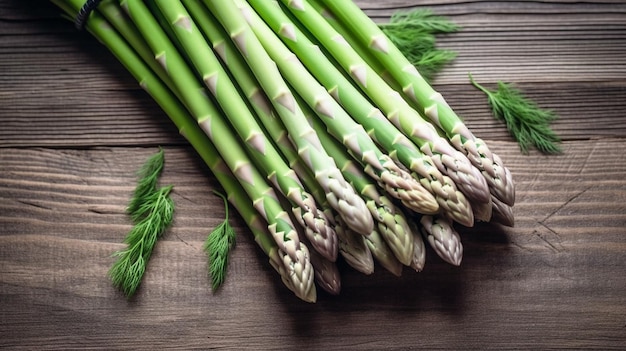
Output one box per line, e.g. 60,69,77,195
204,192,236,291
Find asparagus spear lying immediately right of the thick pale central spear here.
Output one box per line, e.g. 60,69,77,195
236,1,439,214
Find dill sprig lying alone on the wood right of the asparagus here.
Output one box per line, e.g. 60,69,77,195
469,74,561,154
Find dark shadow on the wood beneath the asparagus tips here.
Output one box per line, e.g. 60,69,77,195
277,224,511,334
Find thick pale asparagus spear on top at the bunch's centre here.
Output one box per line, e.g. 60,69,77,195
205,0,374,235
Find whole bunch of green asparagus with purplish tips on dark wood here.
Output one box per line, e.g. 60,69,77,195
51,0,514,302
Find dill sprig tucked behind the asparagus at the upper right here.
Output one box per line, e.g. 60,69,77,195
379,8,459,81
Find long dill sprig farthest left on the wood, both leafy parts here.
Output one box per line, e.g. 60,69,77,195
109,149,174,298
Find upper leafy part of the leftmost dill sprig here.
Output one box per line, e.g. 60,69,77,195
126,148,165,221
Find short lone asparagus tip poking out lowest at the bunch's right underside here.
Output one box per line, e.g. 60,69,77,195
420,216,463,266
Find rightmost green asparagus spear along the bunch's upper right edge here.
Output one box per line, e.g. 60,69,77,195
316,0,515,205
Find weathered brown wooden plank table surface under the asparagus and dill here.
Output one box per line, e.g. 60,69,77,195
0,0,626,350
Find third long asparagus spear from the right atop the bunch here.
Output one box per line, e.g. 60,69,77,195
249,0,482,226
